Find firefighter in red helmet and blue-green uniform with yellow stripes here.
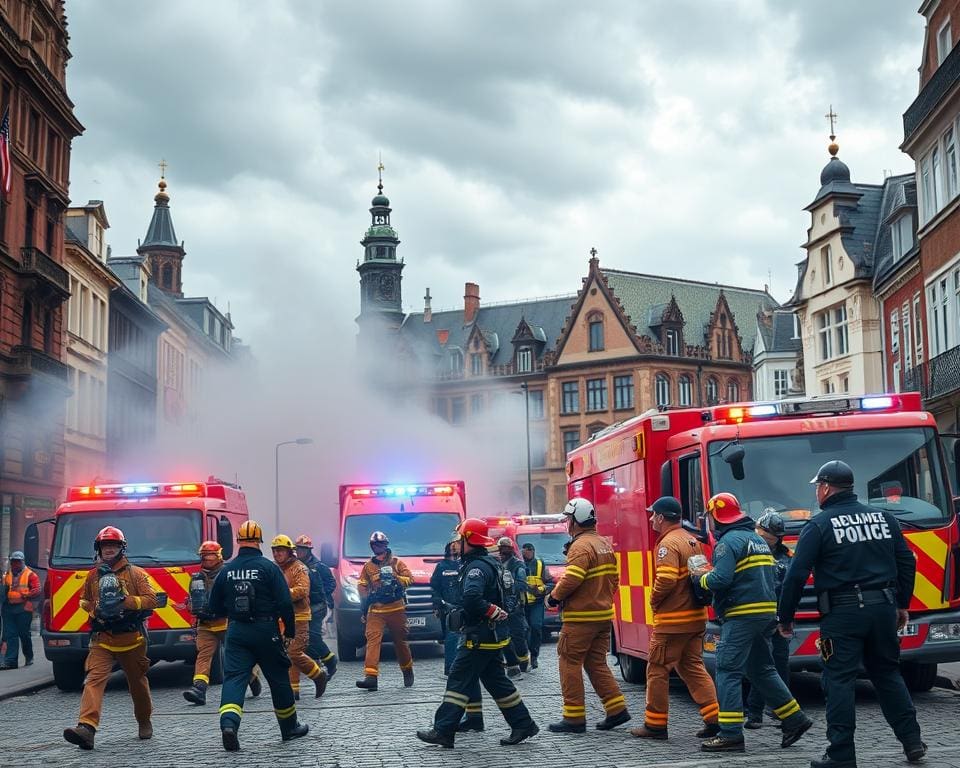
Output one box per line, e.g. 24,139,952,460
690,493,813,752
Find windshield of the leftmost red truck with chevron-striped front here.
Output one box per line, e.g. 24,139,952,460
50,509,200,568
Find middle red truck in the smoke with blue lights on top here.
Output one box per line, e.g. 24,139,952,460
320,481,466,661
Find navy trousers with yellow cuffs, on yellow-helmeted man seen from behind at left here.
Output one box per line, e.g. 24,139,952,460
220,621,297,734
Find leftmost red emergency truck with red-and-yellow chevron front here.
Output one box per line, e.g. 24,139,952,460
24,477,249,691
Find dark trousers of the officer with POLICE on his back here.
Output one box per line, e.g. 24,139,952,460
820,603,920,760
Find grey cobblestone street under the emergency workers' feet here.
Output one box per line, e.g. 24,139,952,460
0,644,960,768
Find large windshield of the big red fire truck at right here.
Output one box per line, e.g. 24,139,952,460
708,428,953,528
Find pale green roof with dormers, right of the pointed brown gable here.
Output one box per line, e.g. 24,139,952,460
601,269,779,351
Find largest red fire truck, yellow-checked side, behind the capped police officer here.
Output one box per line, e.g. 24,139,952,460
567,393,960,691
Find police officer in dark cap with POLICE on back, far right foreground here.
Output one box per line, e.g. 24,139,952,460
779,461,927,768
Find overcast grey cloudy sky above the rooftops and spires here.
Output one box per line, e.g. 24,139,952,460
67,0,923,350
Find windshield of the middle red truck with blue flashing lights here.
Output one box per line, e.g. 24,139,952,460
343,512,460,560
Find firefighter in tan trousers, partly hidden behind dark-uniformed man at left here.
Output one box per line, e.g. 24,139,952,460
183,541,263,706
